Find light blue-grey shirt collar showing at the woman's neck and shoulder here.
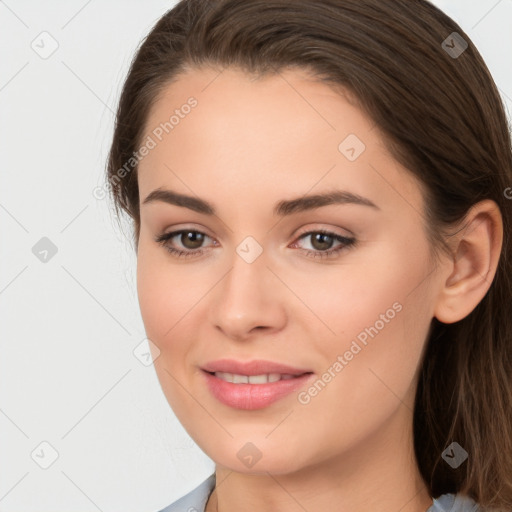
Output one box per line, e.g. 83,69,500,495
159,473,480,512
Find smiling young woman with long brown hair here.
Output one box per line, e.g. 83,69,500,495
108,0,512,512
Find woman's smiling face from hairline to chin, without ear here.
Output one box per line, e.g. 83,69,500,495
137,68,439,474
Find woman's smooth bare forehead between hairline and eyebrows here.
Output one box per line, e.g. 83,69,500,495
139,68,421,216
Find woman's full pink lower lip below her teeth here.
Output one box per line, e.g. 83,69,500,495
203,370,314,410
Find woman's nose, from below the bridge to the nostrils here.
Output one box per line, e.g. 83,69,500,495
209,247,287,341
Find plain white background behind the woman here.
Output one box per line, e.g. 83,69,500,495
0,0,512,512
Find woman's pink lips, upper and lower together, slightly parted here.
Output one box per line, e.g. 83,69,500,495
202,359,314,410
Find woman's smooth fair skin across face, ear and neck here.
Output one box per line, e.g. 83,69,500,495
137,68,503,512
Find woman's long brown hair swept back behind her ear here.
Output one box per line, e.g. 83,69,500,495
107,0,512,512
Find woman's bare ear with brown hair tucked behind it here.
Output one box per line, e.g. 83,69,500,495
434,199,503,324
